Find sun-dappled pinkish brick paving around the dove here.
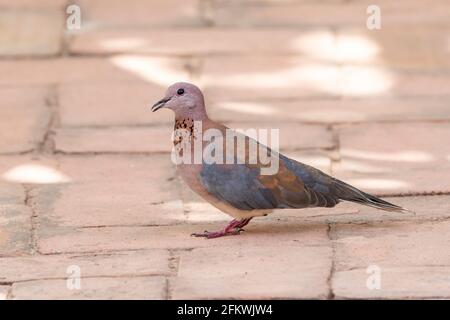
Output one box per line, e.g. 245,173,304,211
0,0,450,299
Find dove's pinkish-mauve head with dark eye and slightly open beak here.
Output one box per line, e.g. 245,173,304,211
152,82,206,120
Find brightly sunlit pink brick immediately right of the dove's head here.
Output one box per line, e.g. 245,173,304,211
199,55,341,102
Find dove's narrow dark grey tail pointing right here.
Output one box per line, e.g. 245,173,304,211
334,179,414,213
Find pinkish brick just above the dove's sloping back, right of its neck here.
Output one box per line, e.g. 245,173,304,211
226,122,334,151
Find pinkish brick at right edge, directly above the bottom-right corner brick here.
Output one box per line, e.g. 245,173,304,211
333,220,450,271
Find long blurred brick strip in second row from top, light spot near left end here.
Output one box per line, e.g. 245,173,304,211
69,28,326,55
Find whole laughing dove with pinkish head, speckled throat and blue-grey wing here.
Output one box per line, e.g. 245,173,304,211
152,82,408,238
